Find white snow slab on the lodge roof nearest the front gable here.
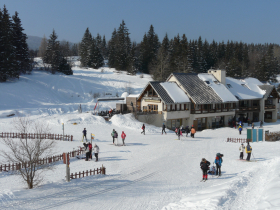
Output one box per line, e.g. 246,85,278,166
160,82,190,103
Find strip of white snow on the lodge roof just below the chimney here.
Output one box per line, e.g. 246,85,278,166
198,73,238,102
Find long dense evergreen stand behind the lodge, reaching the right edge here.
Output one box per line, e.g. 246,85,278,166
83,21,280,81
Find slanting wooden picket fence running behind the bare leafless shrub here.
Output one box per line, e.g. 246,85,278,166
0,149,84,172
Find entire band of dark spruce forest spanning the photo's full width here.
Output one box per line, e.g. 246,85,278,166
0,6,280,82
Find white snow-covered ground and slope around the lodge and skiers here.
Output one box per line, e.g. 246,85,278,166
0,57,280,210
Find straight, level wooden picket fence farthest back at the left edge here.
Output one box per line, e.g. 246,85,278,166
0,132,73,141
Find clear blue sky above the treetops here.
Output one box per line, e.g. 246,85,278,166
0,0,280,44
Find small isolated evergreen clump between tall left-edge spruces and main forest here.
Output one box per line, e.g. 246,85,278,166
39,30,73,75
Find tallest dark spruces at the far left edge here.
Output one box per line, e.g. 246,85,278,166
0,5,32,82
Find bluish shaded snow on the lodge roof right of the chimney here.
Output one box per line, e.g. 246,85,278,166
226,77,263,100
